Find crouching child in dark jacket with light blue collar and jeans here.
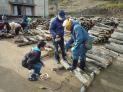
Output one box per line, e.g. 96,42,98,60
22,41,46,81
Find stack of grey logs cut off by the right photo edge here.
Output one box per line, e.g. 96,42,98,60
105,23,123,69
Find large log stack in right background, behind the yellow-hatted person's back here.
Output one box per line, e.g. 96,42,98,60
78,17,118,44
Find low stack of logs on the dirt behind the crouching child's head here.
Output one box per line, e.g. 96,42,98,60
15,28,52,47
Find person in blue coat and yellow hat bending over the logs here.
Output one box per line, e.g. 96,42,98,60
63,19,89,70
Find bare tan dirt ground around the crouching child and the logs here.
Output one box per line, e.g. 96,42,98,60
0,40,123,92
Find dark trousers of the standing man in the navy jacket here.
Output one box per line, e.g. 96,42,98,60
53,37,66,61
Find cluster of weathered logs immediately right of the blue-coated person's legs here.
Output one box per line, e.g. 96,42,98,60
87,46,113,68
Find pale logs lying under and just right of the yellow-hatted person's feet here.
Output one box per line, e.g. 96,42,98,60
57,46,114,89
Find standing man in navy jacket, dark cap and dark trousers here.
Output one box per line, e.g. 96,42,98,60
49,10,66,63
